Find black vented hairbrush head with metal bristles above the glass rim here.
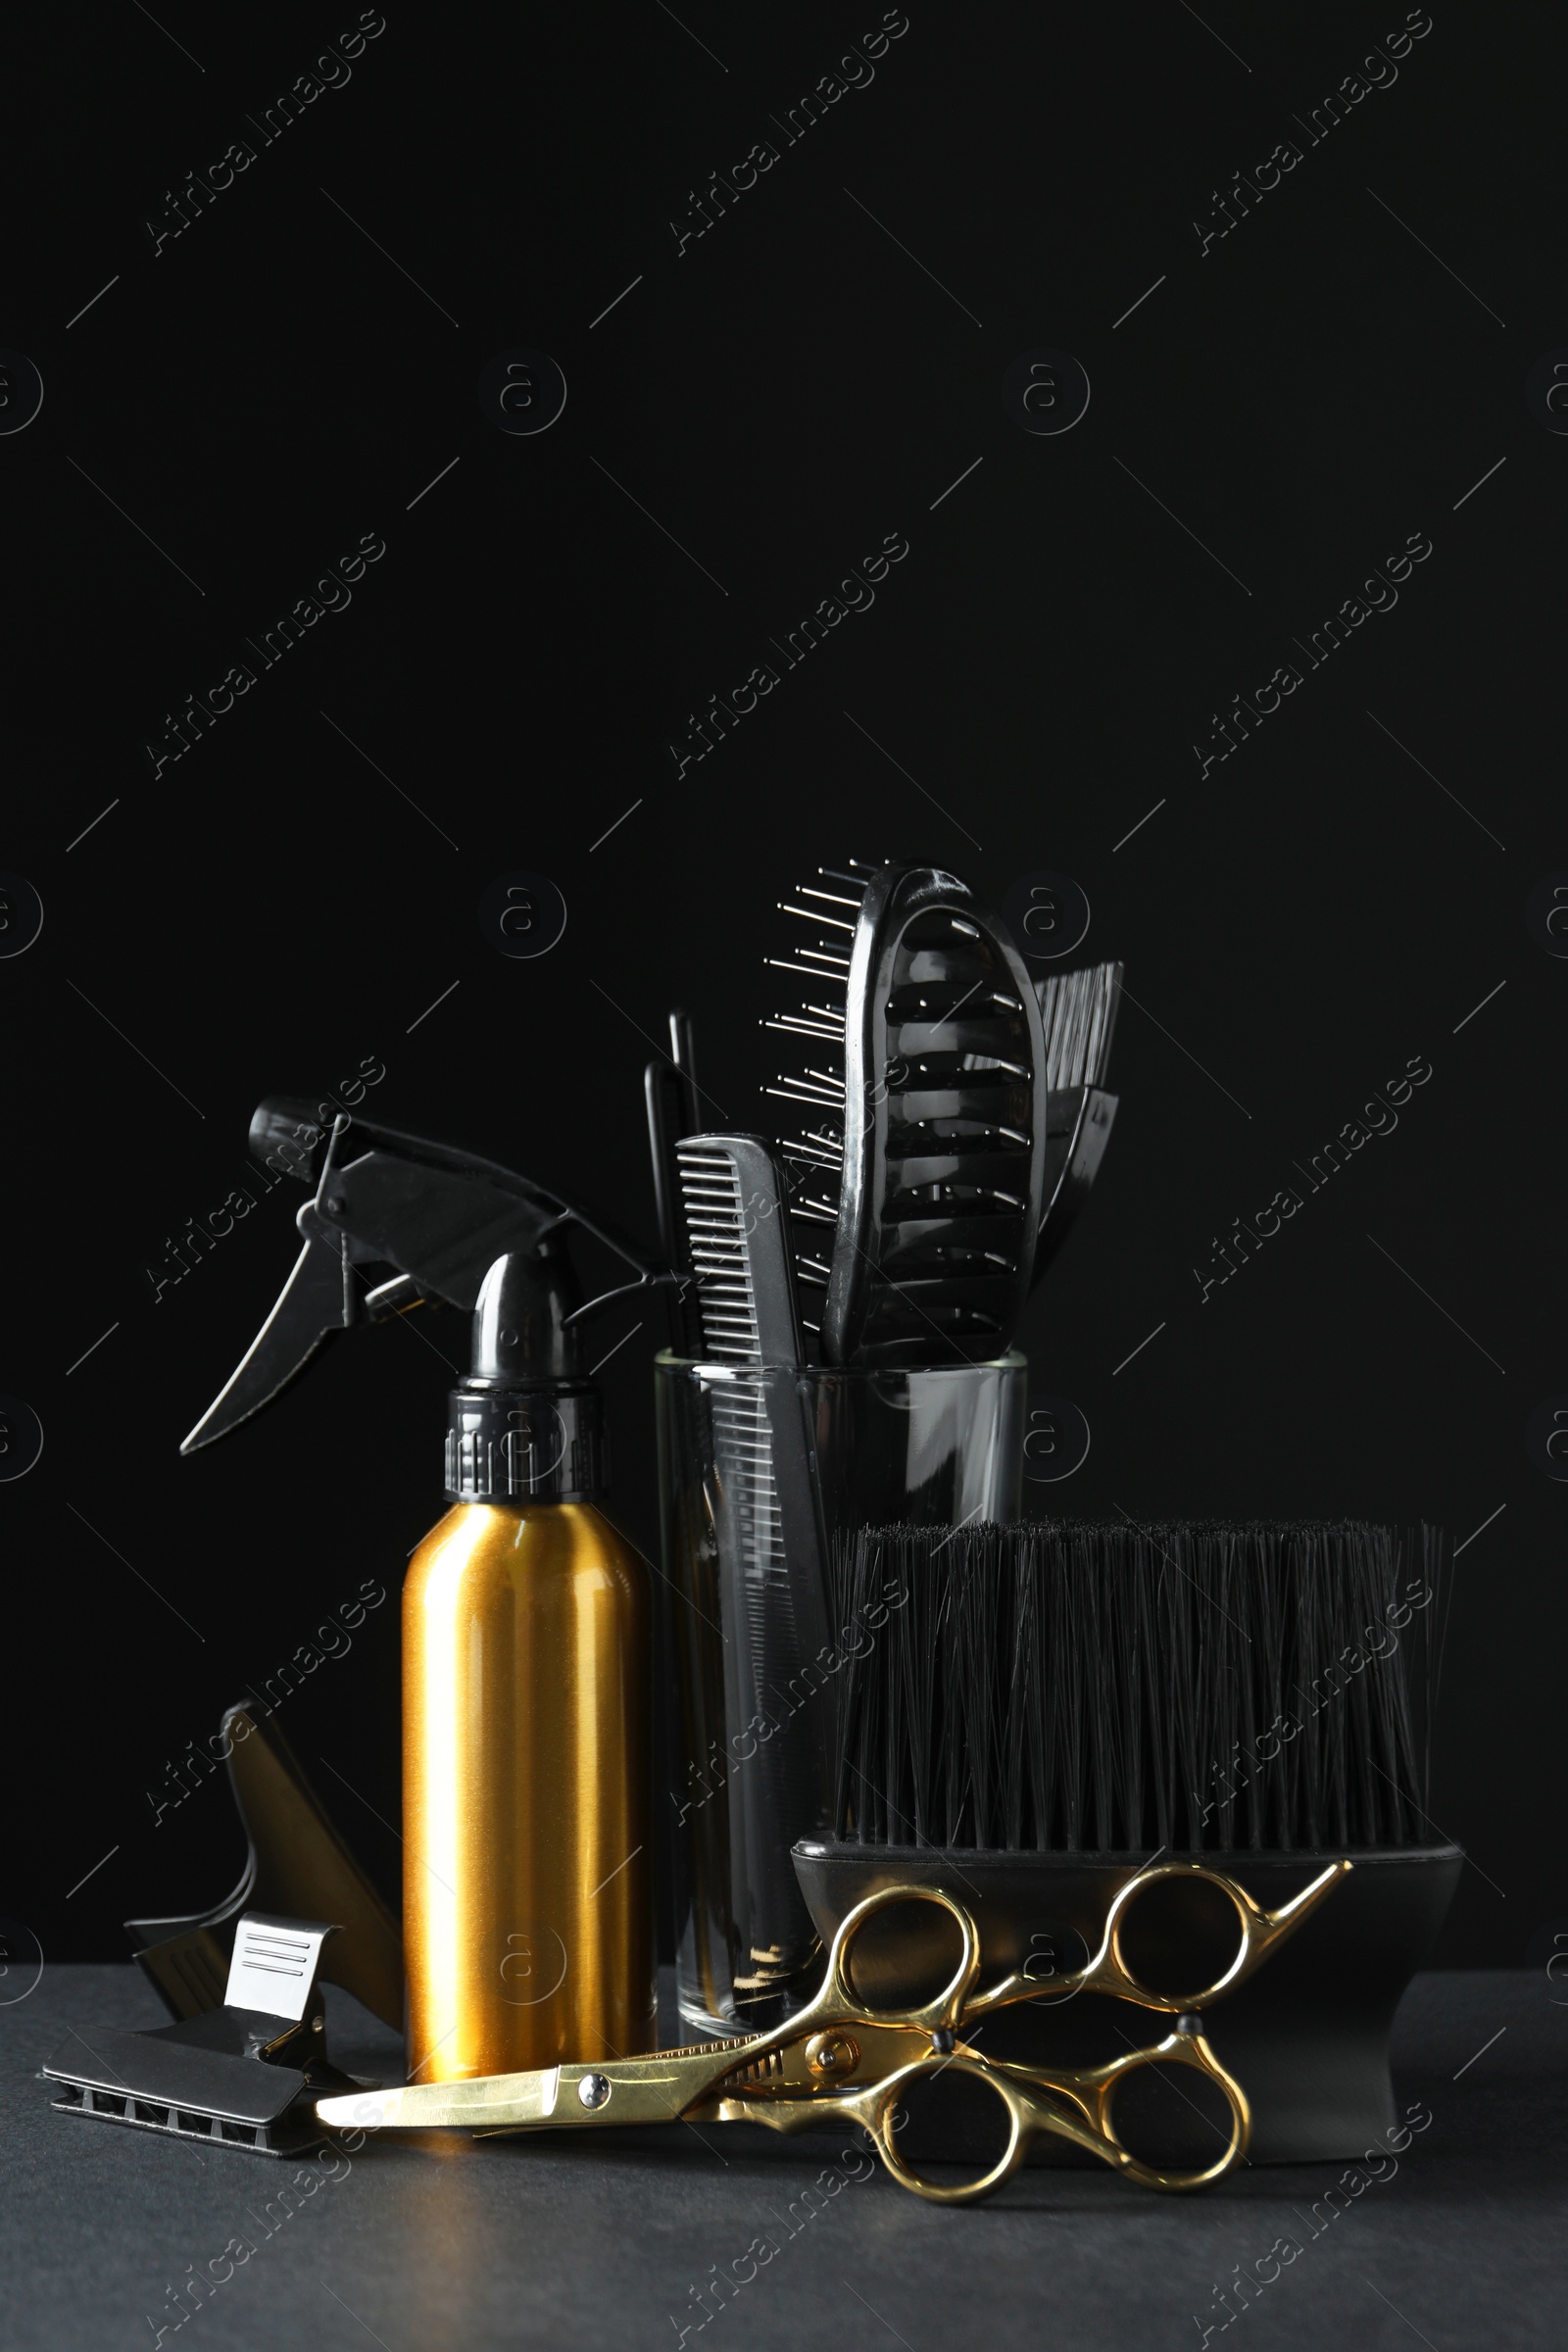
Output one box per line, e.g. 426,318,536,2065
764,860,1046,1366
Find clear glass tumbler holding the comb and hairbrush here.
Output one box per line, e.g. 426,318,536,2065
654,1354,1027,2034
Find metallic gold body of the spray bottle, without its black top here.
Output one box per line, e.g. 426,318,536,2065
402,1503,659,2082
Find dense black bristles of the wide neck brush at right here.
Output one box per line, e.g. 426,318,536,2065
835,1519,1450,1856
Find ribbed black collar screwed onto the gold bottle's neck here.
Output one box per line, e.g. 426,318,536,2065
447,1381,609,1503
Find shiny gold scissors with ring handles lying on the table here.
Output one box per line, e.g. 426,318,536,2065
315,1860,1351,2204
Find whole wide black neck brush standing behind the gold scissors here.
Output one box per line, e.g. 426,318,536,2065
795,1519,1464,2164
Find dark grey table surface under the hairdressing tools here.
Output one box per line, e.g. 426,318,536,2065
0,1966,1568,2352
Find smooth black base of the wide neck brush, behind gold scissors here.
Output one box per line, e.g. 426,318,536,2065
795,1839,1464,2164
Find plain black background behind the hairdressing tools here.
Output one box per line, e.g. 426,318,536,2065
0,0,1568,1964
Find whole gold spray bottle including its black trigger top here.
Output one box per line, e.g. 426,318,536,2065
181,1099,672,2082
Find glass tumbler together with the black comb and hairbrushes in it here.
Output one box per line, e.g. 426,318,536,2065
649,865,1121,2033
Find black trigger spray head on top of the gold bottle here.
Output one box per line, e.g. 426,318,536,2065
181,1096,674,1500
